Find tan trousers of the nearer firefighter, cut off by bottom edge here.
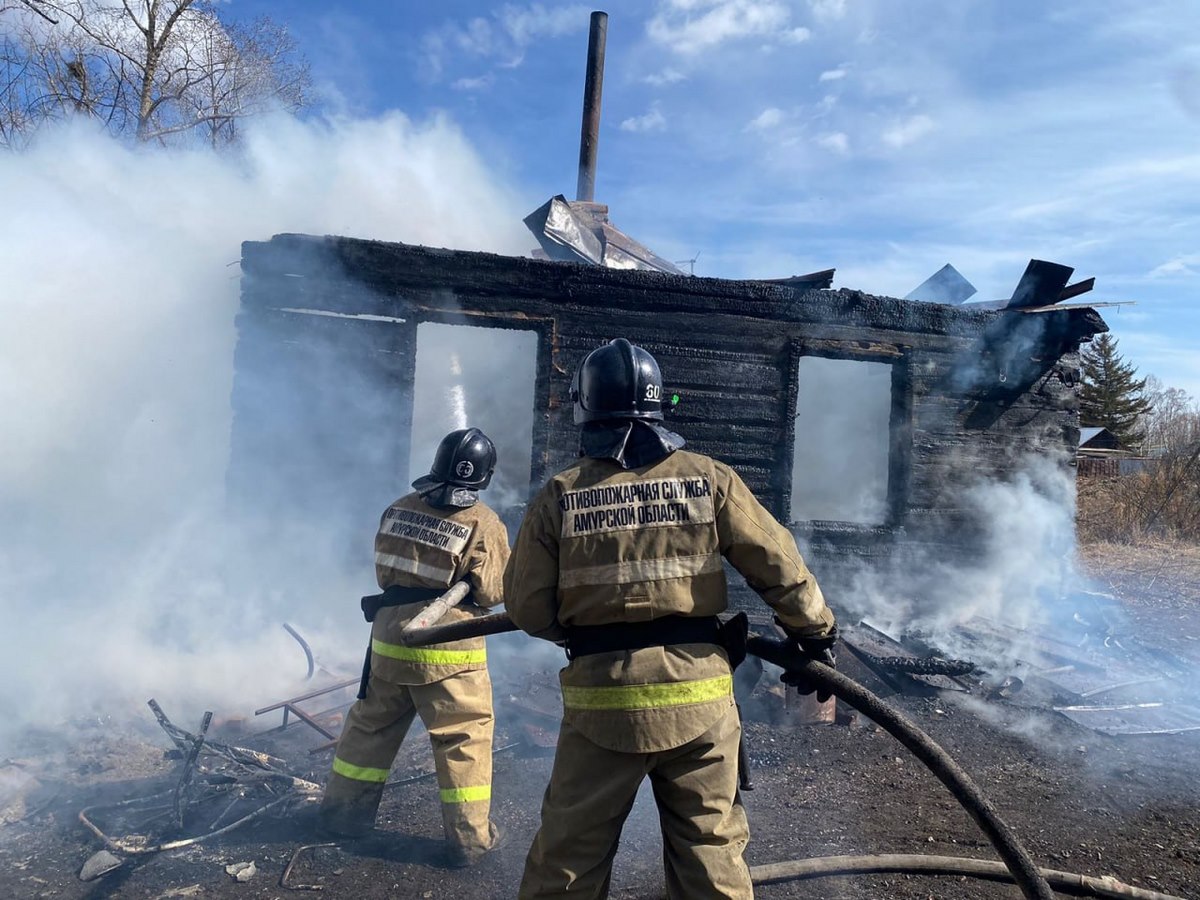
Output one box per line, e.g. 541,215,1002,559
518,708,754,900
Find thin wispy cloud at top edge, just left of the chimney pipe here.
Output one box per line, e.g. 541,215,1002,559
421,4,589,79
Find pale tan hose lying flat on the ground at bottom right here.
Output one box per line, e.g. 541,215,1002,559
750,853,1183,900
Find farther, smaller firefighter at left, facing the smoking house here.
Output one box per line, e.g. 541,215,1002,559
320,428,509,865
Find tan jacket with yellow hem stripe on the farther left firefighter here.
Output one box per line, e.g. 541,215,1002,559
371,493,509,684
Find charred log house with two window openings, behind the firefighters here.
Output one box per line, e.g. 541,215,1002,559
229,235,1105,614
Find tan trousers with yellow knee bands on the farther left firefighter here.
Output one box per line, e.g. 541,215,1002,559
320,668,494,851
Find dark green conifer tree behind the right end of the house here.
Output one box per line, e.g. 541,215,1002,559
1079,332,1152,448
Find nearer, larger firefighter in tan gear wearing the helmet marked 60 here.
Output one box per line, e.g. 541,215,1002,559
504,340,836,899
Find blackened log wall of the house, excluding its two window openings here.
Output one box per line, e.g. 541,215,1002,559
229,235,1105,607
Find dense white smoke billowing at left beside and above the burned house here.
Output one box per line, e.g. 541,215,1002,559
0,113,528,748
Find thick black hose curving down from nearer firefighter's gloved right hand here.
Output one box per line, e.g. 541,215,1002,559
746,635,1054,900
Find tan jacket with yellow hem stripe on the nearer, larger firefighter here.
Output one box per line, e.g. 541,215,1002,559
505,450,834,752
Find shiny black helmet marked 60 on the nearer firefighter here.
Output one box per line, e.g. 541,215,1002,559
571,337,662,425
